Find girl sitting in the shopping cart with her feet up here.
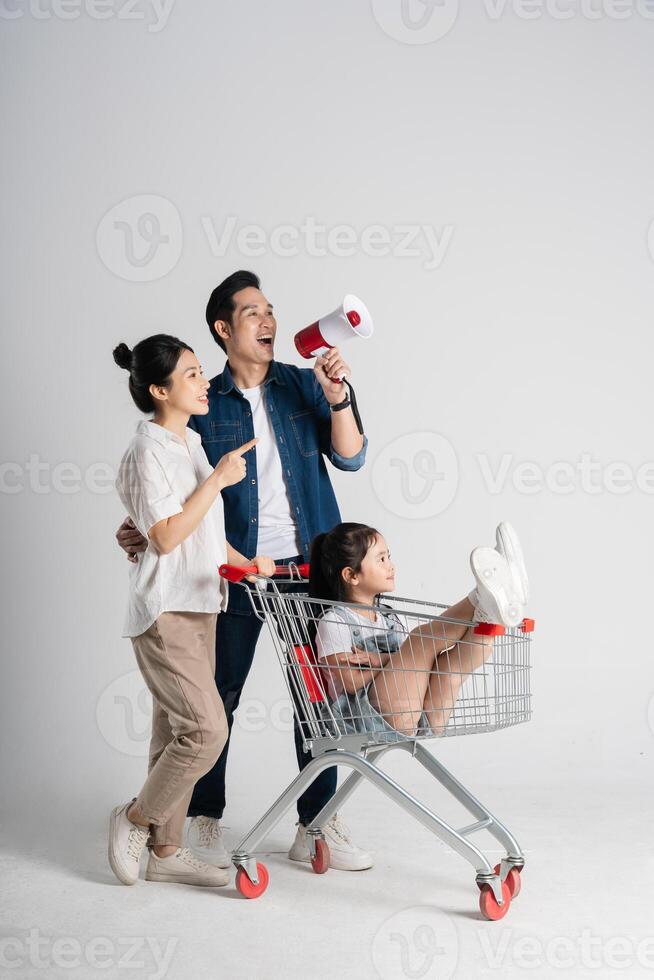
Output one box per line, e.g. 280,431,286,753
309,523,528,738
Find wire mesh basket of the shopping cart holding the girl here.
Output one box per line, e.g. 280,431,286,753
250,571,533,748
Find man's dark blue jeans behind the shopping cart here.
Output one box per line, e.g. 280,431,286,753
188,555,337,826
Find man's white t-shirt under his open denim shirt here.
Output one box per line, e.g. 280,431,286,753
241,385,301,558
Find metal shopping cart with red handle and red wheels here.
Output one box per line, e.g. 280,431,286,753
220,564,534,920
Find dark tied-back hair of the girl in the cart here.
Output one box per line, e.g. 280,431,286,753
309,523,379,602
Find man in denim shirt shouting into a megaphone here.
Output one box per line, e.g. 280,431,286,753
116,271,372,871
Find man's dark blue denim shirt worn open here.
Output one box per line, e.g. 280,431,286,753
189,361,368,613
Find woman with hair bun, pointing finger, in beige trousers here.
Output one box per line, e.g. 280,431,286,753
109,334,273,885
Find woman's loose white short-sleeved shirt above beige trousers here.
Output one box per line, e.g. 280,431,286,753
116,421,227,636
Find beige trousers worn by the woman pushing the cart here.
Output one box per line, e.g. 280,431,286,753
132,612,227,847
